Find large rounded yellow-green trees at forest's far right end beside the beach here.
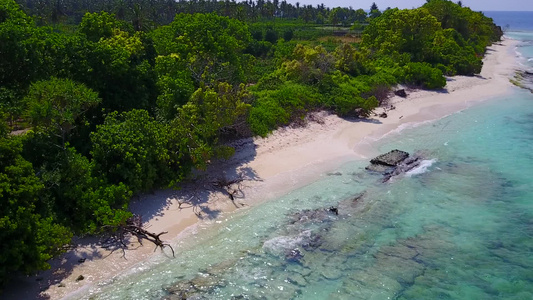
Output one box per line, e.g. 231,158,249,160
361,0,492,77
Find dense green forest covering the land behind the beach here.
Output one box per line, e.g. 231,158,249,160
0,0,502,286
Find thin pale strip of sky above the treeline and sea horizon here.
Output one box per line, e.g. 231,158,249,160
287,0,533,11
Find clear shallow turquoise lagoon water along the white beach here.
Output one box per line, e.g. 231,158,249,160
73,40,533,299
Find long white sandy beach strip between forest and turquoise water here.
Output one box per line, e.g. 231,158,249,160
3,40,516,299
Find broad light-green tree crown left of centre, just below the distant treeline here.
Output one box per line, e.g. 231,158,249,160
151,14,251,84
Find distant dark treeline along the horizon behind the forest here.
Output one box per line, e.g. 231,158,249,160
16,0,380,30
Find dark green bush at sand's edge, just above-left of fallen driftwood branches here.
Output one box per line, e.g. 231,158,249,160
35,148,131,233
